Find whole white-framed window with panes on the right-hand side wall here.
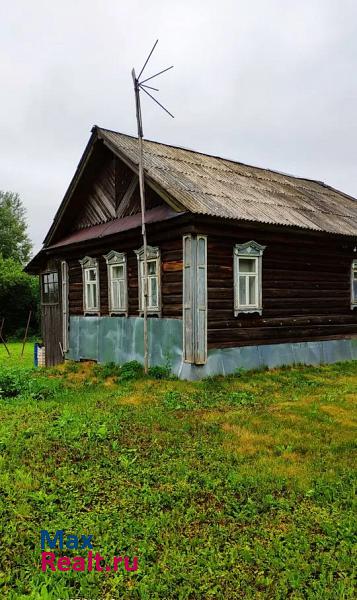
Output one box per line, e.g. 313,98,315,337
234,241,265,316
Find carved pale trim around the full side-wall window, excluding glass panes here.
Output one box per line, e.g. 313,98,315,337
233,240,266,317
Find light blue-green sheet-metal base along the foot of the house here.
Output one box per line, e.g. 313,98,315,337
67,317,357,379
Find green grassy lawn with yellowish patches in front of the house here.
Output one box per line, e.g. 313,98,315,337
0,344,357,600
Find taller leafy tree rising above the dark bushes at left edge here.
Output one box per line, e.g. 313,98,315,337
0,191,32,264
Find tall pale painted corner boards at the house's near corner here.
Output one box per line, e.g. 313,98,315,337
183,235,207,365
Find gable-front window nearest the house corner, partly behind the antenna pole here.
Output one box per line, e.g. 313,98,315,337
135,246,161,313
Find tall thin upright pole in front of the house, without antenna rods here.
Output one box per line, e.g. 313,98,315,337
132,69,149,373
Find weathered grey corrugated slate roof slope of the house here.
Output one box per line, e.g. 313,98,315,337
95,127,357,236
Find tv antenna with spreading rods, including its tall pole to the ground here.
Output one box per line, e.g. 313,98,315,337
131,40,174,373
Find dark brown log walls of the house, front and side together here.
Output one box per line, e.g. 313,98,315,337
50,220,357,348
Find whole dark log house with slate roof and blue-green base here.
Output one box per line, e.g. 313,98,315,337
27,126,357,378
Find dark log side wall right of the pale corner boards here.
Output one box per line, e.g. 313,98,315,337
206,227,357,348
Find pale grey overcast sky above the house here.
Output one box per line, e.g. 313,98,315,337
0,0,357,250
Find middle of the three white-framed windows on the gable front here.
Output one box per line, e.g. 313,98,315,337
104,250,128,314
